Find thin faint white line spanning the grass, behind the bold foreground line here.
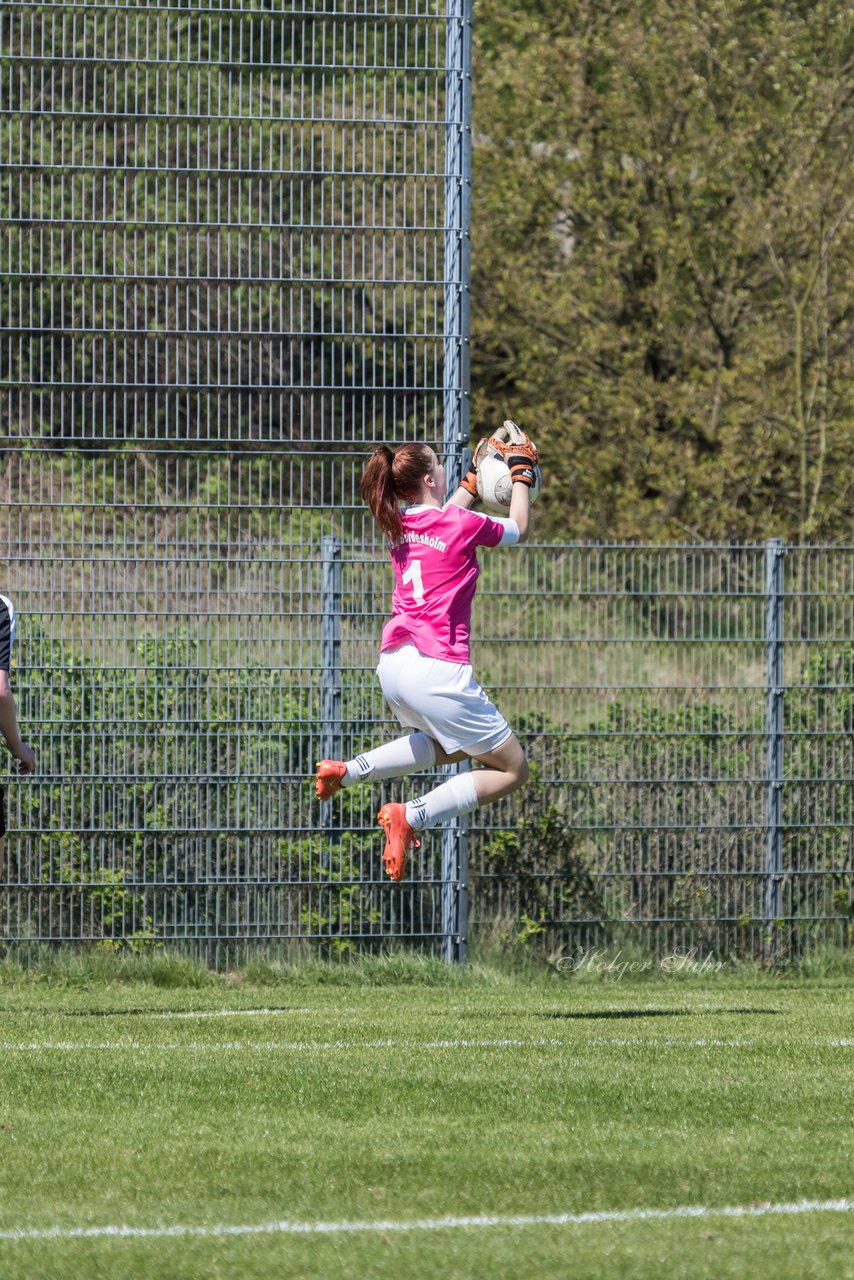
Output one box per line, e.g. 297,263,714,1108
0,1036,854,1053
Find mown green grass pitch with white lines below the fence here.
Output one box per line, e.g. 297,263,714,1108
0,960,854,1280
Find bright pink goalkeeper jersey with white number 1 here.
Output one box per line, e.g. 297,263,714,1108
380,504,516,663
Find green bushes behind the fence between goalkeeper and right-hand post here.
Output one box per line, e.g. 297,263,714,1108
479,699,750,945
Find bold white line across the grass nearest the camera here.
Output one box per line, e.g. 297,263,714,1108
0,1199,854,1242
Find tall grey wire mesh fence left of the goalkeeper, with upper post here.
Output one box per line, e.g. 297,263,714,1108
0,0,463,960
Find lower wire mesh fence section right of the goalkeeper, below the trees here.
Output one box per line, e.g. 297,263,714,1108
471,540,854,956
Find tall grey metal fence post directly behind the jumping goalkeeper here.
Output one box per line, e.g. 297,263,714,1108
442,0,472,964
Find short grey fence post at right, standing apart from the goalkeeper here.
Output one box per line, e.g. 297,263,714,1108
764,538,785,957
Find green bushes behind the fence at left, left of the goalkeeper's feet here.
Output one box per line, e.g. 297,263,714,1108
5,621,320,947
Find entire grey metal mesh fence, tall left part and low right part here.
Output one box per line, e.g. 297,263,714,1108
0,0,854,963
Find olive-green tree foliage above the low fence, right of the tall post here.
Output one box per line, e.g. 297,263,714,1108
472,0,854,540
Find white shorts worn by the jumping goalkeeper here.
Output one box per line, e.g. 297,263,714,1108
376,644,512,755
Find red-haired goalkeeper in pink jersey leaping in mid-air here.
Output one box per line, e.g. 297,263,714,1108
316,424,536,881
